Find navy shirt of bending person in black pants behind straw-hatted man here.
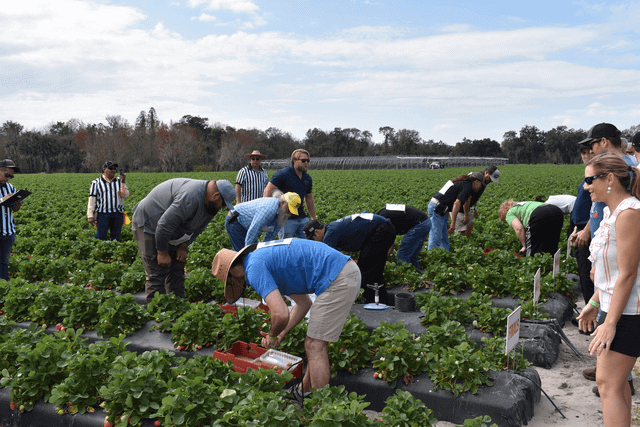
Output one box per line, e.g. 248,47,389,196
323,214,389,252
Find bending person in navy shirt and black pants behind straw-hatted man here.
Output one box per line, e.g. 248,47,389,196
304,213,396,305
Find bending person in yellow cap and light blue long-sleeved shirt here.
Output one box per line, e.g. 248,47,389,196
224,191,300,251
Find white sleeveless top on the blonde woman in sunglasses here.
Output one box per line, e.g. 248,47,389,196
589,197,640,315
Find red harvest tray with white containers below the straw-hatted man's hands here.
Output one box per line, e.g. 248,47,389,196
213,341,302,378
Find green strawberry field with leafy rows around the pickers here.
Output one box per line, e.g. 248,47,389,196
0,165,584,426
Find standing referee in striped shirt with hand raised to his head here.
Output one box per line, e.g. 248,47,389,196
87,160,129,241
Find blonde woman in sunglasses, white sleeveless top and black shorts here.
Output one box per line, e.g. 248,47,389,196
578,153,640,426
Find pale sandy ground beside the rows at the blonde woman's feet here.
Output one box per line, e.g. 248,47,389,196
438,300,640,427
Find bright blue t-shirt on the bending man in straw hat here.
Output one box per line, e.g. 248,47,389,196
244,239,350,298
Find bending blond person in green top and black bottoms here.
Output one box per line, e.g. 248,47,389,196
498,200,564,256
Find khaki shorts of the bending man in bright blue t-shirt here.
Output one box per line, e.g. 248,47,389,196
307,259,361,342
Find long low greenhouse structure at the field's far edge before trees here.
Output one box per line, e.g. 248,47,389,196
262,156,509,170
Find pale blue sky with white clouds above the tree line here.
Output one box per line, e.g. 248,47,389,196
0,0,640,145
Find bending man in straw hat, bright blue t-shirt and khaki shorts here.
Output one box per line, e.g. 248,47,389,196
211,239,360,401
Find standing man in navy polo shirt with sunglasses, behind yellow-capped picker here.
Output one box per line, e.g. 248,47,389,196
263,148,316,241
